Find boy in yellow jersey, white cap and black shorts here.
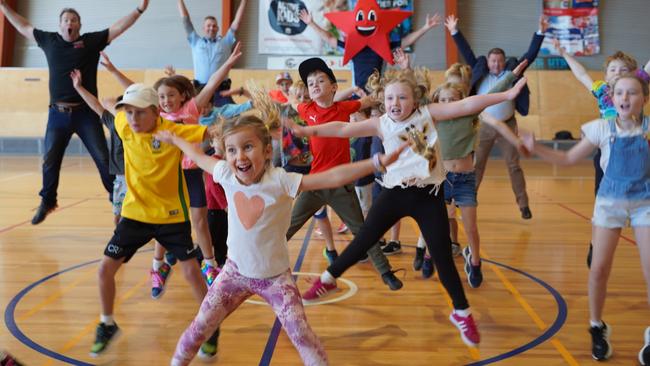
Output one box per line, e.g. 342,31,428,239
90,84,218,356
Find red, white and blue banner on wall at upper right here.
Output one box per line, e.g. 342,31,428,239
541,0,600,56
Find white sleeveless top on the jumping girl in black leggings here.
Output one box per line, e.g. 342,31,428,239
379,106,445,188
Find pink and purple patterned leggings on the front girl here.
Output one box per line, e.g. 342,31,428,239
172,260,328,366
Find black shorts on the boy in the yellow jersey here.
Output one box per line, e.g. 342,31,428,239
104,217,197,263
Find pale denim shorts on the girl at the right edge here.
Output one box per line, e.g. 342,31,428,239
591,196,650,229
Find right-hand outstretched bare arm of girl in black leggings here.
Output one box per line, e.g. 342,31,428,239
427,78,526,121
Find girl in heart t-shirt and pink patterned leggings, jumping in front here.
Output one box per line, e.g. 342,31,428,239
156,116,406,365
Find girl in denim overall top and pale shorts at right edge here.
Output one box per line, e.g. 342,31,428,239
522,74,650,365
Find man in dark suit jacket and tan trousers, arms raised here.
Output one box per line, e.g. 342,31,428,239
445,15,547,219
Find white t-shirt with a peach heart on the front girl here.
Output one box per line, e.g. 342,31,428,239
212,160,302,278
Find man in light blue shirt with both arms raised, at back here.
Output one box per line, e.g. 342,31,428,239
178,0,247,107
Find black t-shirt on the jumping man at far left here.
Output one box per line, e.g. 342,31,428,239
34,29,108,103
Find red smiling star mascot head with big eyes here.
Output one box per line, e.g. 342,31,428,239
325,0,412,65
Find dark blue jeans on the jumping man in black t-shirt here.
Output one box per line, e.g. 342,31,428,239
39,105,114,206
